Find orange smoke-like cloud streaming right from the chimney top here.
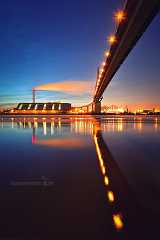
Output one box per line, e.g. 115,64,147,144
34,80,95,95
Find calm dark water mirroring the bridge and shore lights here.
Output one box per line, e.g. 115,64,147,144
0,116,160,240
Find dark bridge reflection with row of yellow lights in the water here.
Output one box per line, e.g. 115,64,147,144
93,121,159,239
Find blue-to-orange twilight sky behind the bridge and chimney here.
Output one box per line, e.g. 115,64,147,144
0,0,160,109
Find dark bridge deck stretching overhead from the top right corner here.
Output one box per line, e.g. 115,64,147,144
94,0,160,101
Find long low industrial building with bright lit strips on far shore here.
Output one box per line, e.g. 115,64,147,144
14,102,71,114
